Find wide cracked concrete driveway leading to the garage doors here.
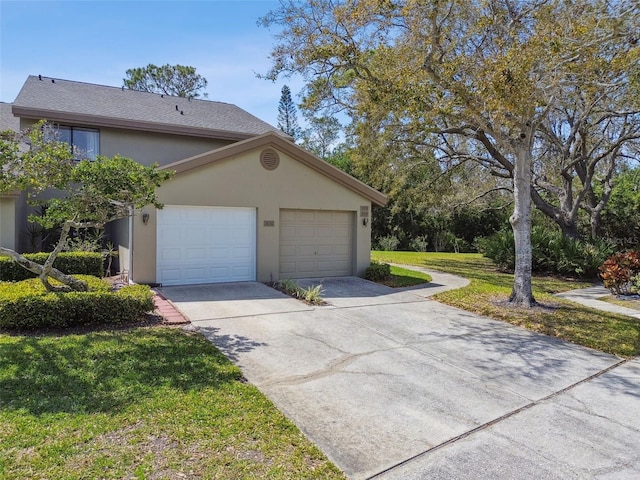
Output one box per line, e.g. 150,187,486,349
162,277,640,479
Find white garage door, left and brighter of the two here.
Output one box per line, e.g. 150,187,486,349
157,206,256,285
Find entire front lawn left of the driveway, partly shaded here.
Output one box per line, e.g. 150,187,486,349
0,327,344,479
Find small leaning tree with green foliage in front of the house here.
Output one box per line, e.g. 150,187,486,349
0,122,172,291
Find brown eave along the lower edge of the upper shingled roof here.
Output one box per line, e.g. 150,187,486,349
11,105,255,141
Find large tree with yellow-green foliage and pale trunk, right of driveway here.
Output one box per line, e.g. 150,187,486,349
264,0,640,306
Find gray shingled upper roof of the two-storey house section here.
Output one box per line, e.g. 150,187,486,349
13,75,281,138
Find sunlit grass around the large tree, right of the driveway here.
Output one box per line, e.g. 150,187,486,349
371,252,640,357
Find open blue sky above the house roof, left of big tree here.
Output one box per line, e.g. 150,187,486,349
0,0,302,126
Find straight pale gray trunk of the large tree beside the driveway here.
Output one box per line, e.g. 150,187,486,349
509,139,535,308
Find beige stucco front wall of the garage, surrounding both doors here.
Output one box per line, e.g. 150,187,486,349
134,149,371,282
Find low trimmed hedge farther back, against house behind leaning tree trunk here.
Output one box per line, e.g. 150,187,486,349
0,252,104,282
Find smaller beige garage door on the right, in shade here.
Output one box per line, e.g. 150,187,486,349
280,210,353,278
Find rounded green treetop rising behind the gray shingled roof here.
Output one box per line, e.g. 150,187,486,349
122,63,207,98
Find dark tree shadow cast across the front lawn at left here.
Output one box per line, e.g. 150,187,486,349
0,328,241,415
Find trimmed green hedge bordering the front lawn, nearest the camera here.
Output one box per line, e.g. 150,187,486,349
0,275,154,330
